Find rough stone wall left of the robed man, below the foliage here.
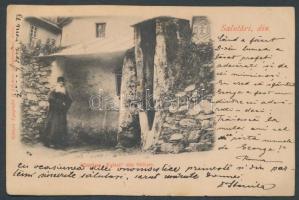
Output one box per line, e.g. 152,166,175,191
21,61,51,144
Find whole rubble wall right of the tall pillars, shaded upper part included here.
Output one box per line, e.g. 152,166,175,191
154,17,214,153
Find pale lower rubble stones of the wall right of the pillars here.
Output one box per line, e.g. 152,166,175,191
158,84,214,153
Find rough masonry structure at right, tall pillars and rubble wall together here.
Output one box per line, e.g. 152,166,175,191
120,16,214,153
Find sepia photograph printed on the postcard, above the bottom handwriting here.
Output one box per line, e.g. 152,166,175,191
20,16,214,153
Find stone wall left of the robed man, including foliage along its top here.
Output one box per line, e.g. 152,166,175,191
20,42,59,144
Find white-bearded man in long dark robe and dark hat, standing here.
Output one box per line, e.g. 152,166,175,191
42,77,72,148
